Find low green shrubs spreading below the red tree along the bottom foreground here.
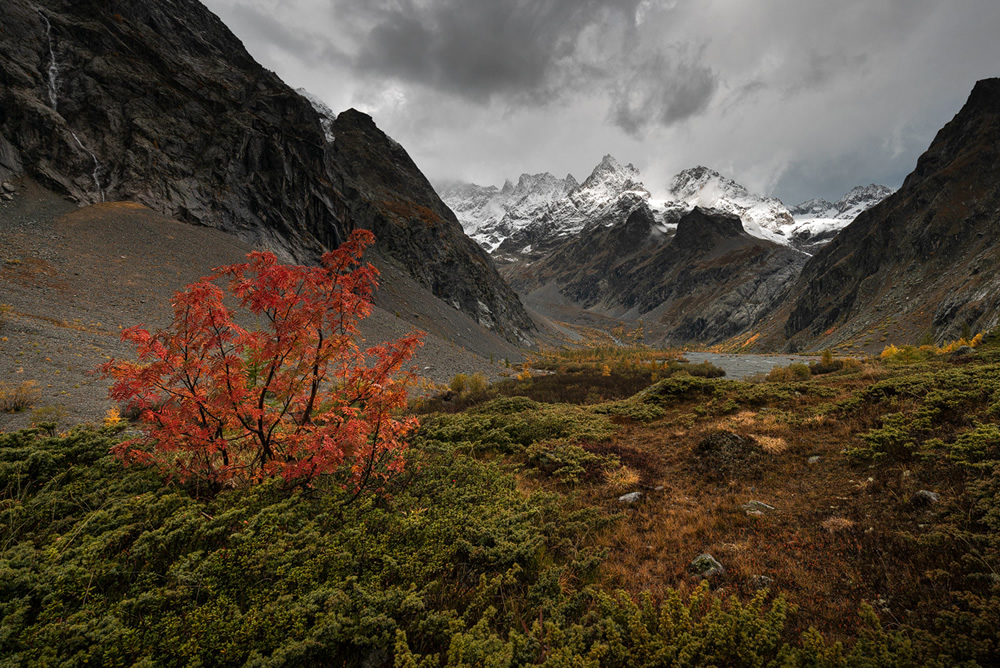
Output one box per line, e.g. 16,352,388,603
0,429,947,666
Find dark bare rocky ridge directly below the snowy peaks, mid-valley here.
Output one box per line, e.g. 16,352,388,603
504,207,806,343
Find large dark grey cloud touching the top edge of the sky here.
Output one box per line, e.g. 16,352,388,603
338,0,639,104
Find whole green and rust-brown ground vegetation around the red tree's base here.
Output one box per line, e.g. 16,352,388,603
0,340,1000,666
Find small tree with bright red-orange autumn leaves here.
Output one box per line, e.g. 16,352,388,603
101,230,420,490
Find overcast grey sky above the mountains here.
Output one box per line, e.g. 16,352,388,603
203,0,1000,204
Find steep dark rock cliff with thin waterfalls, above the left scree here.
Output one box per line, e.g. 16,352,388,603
0,0,532,342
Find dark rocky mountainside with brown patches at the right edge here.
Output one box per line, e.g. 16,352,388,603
783,79,1000,346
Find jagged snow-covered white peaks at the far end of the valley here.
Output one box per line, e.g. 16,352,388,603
438,155,893,253
